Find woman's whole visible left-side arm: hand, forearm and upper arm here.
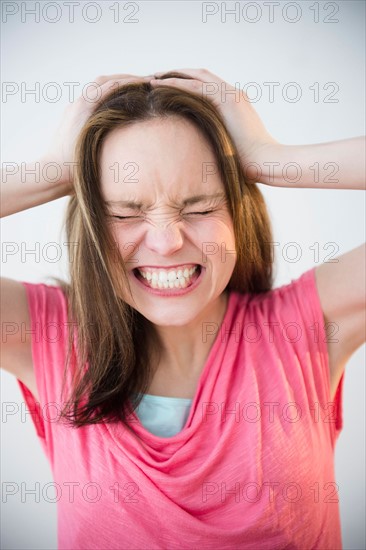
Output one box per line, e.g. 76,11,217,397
0,75,150,397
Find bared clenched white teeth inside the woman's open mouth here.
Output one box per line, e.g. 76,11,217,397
132,264,202,290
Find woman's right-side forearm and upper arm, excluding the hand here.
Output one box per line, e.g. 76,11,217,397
253,137,366,398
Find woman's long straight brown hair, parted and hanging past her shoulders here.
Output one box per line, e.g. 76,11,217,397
57,72,273,427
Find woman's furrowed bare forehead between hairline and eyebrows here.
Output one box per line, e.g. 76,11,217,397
100,117,223,200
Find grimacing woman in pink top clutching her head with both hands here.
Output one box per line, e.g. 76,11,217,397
2,69,365,549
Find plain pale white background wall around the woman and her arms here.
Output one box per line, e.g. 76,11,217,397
1,1,365,549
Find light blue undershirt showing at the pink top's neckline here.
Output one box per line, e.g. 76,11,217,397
135,394,192,437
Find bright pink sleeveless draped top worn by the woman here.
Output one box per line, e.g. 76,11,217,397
18,268,343,550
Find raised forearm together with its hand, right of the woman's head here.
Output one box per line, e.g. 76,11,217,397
151,69,366,189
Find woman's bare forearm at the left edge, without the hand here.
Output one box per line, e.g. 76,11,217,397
0,159,71,218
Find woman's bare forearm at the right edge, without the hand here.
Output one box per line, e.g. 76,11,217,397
250,136,366,189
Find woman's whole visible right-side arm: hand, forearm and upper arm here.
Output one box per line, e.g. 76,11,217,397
152,69,366,397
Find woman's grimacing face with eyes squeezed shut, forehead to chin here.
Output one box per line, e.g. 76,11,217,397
101,117,236,326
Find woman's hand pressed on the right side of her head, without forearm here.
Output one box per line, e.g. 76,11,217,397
151,69,281,183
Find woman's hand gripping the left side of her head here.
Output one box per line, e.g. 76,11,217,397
39,74,153,195
